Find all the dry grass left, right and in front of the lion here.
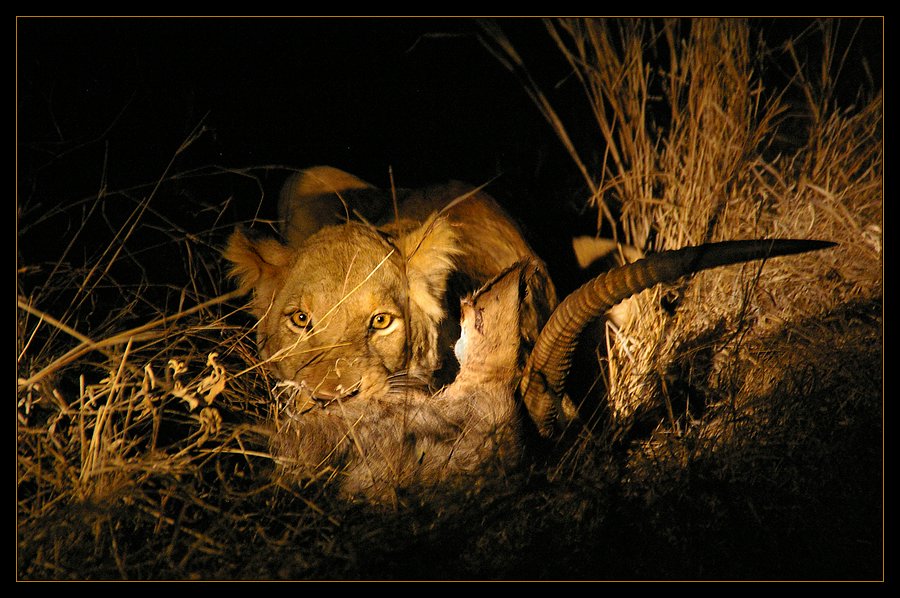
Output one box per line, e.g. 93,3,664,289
17,20,884,579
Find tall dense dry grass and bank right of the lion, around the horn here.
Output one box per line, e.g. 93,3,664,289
495,19,883,577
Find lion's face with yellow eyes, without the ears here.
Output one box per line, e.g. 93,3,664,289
259,226,409,398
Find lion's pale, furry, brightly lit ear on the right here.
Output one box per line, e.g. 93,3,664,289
397,214,460,322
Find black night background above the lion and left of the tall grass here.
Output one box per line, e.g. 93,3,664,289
17,18,599,288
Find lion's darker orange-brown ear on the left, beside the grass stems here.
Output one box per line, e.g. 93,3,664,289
223,230,292,317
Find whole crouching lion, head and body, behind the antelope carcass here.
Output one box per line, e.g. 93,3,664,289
225,166,557,408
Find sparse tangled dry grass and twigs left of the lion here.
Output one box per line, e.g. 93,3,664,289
16,137,312,578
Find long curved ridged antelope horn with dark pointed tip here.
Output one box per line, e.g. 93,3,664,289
519,239,835,437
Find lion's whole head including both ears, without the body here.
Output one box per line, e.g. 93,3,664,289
225,219,455,401
